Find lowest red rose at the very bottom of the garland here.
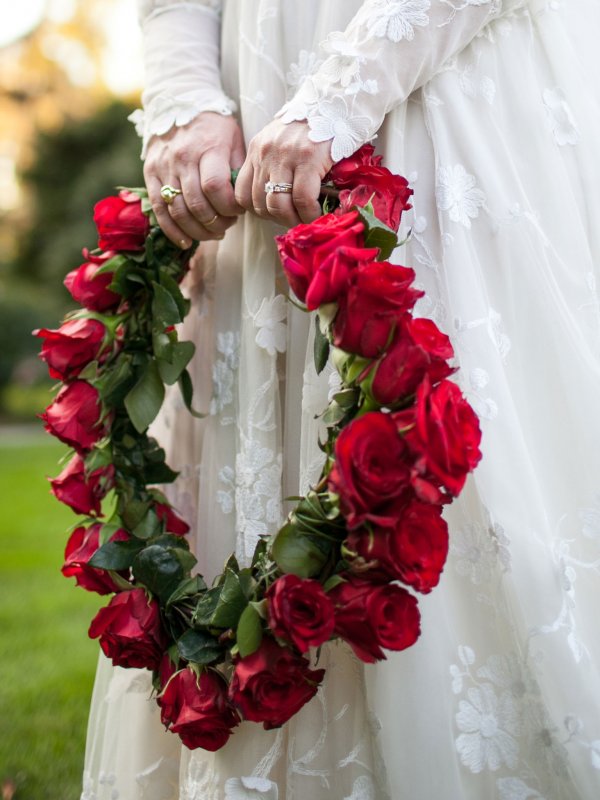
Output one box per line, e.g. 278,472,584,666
156,667,240,752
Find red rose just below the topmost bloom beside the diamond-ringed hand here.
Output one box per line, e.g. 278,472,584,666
337,165,413,231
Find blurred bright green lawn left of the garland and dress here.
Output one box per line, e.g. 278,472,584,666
0,428,103,800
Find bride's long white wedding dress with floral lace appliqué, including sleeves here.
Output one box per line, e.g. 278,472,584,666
82,0,600,800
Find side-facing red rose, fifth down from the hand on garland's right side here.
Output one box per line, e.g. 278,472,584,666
367,314,454,405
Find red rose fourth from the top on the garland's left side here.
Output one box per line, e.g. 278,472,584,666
40,381,107,452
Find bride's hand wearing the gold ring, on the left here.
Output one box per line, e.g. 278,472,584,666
144,111,245,249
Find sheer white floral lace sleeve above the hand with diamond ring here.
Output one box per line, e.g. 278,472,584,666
276,0,525,161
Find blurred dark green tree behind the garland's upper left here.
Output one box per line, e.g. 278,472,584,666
10,101,143,300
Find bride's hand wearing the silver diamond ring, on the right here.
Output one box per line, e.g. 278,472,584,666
235,119,333,227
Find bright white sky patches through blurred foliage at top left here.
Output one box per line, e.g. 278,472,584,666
0,0,142,94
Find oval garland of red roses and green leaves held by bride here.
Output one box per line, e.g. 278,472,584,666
36,146,480,750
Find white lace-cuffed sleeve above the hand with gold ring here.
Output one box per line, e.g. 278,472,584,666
130,0,236,158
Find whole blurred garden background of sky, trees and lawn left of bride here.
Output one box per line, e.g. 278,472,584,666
0,0,142,800
